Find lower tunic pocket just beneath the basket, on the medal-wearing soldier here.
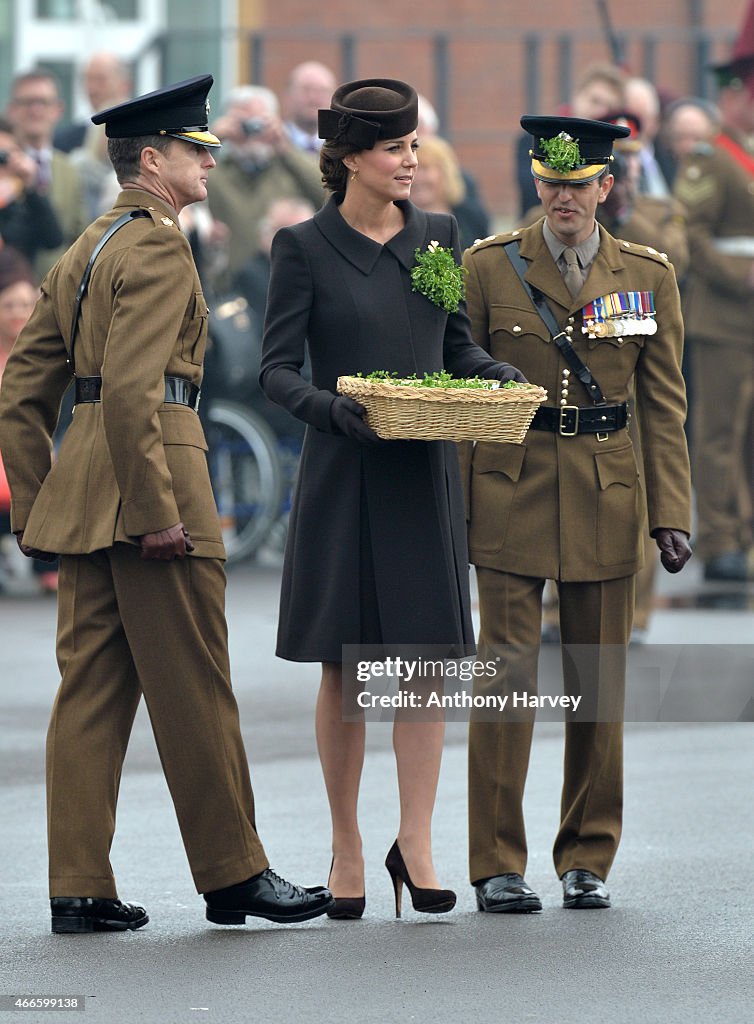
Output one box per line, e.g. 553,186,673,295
468,441,527,553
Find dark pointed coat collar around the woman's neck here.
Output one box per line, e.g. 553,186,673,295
313,194,429,274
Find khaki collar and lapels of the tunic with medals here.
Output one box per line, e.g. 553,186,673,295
520,218,626,313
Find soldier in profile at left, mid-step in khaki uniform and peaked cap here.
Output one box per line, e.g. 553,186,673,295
0,75,332,932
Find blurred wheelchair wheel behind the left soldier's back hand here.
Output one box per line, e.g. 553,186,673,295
208,400,283,565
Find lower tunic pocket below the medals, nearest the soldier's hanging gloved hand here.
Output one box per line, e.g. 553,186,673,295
594,444,643,565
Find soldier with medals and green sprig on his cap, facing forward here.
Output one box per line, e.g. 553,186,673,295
464,117,690,913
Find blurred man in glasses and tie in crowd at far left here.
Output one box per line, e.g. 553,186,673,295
6,68,89,281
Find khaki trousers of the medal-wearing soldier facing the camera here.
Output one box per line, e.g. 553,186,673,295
468,567,634,884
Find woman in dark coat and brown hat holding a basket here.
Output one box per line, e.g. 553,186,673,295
260,79,523,918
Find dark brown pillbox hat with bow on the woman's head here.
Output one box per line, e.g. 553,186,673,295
319,78,419,150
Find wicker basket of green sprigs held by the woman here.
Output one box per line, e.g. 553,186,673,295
337,377,547,442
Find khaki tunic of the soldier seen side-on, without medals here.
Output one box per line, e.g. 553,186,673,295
0,189,224,558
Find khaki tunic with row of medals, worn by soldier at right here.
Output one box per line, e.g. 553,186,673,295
464,221,690,581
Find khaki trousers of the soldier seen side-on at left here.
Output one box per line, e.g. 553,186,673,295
47,544,267,899
